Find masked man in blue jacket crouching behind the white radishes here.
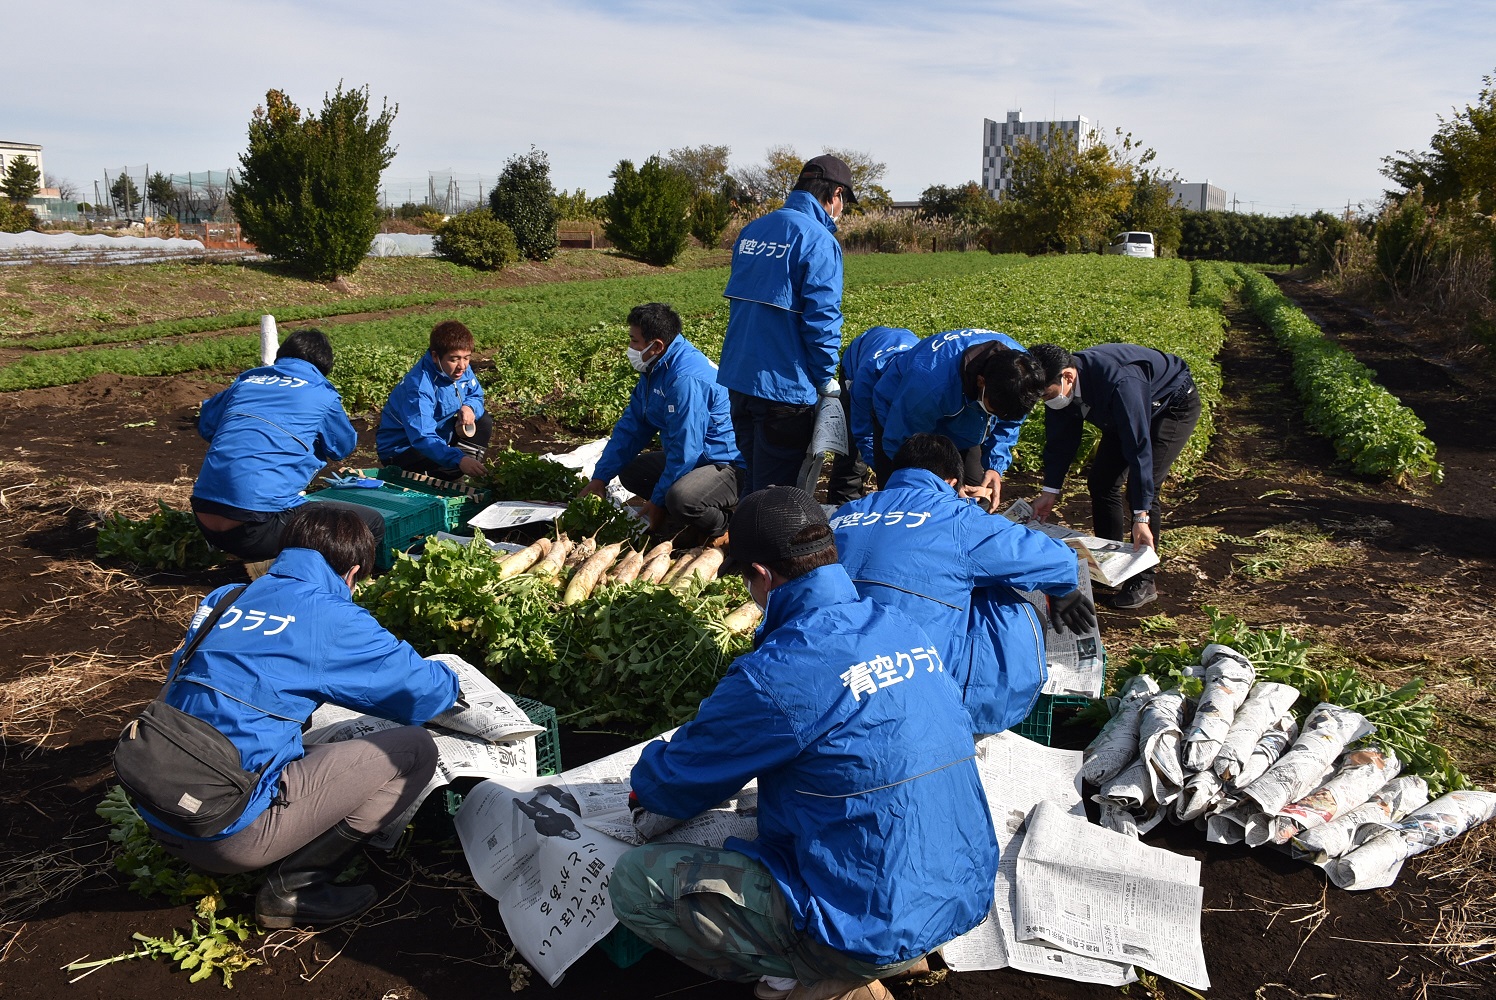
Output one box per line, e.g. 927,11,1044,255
582,302,742,539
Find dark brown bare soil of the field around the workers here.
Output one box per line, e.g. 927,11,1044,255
0,287,1496,1000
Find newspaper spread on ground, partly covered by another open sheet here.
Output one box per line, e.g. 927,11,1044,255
944,732,1137,987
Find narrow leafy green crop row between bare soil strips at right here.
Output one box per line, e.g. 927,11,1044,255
1237,265,1444,484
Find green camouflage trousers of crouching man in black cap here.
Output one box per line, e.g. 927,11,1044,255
607,844,916,984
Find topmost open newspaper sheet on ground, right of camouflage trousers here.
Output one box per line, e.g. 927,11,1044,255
1017,801,1210,990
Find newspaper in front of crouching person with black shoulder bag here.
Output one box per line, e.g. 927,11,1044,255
302,653,545,849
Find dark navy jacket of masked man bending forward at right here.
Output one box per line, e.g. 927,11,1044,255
1044,344,1194,510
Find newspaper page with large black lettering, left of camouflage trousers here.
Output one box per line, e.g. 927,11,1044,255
456,734,758,987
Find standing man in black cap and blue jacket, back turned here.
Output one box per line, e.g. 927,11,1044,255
717,154,857,494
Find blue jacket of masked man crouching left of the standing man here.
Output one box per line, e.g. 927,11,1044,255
592,335,742,507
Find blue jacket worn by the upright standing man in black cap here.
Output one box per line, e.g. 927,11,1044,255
717,192,842,406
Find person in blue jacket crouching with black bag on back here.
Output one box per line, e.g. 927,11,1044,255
142,503,458,927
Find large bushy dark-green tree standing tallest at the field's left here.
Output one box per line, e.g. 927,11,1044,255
229,82,399,278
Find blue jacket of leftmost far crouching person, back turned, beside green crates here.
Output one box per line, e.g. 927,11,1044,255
191,358,359,521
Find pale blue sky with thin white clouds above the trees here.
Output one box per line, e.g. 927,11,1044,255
11,0,1496,213
